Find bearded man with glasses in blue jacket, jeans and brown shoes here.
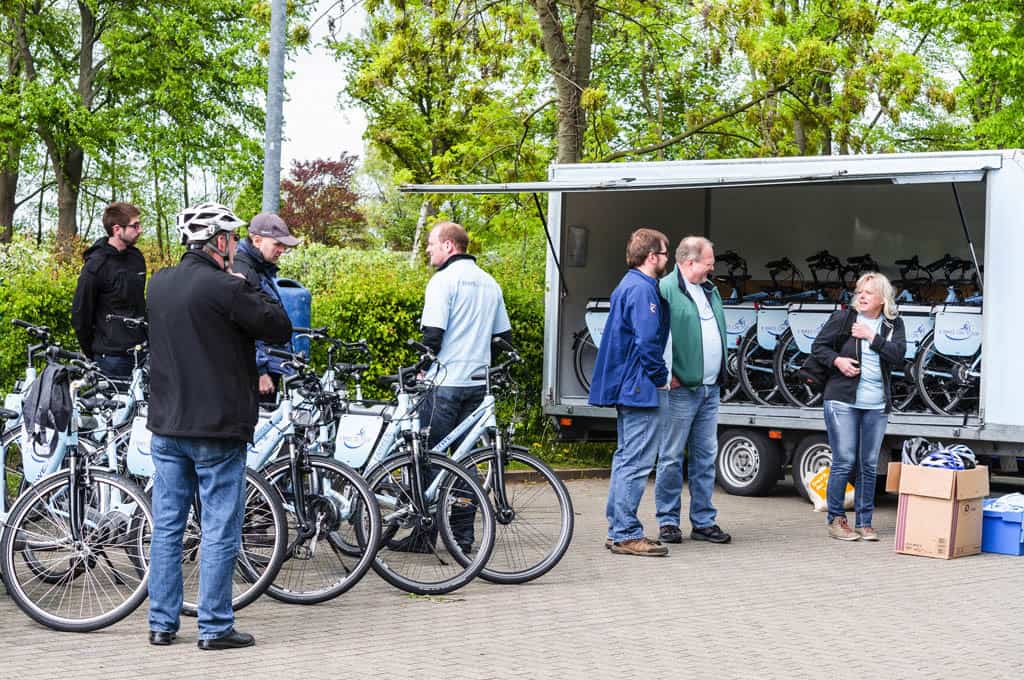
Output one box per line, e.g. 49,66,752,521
590,228,669,557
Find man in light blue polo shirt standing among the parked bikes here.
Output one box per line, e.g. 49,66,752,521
420,222,512,449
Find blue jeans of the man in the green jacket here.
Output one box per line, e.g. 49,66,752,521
654,385,719,528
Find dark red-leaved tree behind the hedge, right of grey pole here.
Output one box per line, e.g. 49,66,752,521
279,153,369,247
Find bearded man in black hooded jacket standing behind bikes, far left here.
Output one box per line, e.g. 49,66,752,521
71,203,145,378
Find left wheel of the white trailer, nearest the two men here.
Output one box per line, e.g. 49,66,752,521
716,429,782,496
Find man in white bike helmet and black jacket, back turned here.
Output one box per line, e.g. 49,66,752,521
148,203,292,649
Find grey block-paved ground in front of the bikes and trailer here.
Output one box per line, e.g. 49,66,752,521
0,480,1024,680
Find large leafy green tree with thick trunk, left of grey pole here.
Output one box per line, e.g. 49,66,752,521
7,0,276,255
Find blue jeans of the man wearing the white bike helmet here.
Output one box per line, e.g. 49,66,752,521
150,434,246,640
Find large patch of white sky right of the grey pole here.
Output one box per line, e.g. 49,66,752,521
281,0,367,166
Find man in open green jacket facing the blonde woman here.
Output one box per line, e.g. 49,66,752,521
654,237,732,543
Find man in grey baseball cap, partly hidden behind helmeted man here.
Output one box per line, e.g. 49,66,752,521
232,213,301,401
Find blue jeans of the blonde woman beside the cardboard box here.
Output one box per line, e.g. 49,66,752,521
824,399,889,526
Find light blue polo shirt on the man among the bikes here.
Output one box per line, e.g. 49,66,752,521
420,258,512,387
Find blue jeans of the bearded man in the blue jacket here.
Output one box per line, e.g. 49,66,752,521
604,389,669,543
